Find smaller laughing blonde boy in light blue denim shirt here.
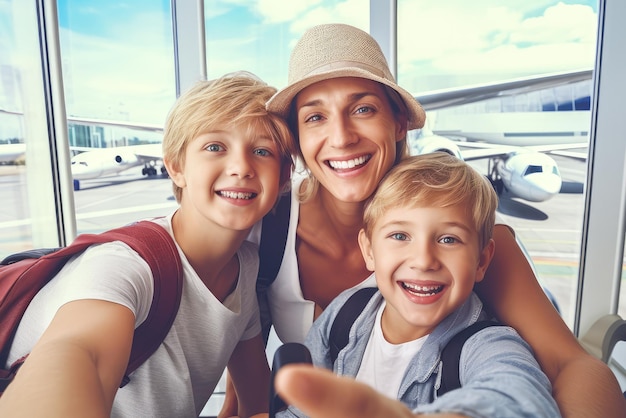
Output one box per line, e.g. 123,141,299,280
276,153,560,417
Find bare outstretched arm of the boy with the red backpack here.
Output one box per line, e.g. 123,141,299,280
0,300,135,418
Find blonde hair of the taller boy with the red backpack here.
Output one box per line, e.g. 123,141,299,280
163,71,295,202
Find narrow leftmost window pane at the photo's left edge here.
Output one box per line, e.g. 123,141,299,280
0,0,50,258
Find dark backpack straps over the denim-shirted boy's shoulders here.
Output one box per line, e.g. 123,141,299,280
329,287,504,397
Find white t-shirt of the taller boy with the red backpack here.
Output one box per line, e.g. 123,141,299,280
8,214,261,418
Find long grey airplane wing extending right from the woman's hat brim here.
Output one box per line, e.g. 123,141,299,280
415,69,593,111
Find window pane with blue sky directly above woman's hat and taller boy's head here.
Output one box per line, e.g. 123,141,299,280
204,0,370,88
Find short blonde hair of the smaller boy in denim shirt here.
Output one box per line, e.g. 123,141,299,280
363,152,498,248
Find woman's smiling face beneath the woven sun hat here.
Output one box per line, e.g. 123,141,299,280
296,77,406,202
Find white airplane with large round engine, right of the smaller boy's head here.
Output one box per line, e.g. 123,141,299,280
407,70,592,202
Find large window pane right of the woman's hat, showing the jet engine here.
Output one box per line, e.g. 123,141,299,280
398,0,598,327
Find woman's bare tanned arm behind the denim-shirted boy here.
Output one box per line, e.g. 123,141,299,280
476,225,626,418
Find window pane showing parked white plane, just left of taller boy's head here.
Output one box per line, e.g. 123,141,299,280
58,0,176,233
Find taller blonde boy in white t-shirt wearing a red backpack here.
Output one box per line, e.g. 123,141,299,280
0,74,293,418
